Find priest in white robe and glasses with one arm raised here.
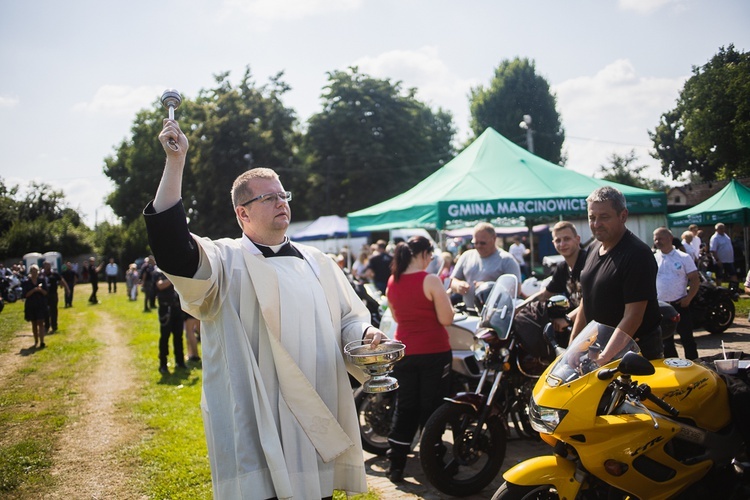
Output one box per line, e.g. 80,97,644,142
144,120,385,499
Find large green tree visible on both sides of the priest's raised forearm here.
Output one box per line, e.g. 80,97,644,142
104,68,299,238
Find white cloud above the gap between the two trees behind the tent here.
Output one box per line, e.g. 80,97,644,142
352,46,477,140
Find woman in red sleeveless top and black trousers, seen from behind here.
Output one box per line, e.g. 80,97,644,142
386,236,453,482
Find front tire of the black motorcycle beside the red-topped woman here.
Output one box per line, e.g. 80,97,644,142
419,403,507,497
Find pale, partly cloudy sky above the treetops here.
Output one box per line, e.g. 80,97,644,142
0,0,750,225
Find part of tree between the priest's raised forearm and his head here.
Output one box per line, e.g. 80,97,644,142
185,68,300,237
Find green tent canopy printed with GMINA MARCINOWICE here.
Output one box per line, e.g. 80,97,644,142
347,128,667,231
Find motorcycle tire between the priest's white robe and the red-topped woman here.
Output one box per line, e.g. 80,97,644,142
354,387,396,457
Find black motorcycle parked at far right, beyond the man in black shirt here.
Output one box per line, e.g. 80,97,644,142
690,271,738,334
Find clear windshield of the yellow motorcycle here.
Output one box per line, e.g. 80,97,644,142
548,321,641,383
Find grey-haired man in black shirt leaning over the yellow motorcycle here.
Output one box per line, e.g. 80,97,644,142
571,186,664,365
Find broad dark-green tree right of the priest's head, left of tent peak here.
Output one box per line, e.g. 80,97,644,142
302,68,454,217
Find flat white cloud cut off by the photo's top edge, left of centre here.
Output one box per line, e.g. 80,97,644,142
222,0,363,20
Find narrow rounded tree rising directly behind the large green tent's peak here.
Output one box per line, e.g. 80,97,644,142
469,58,565,164
